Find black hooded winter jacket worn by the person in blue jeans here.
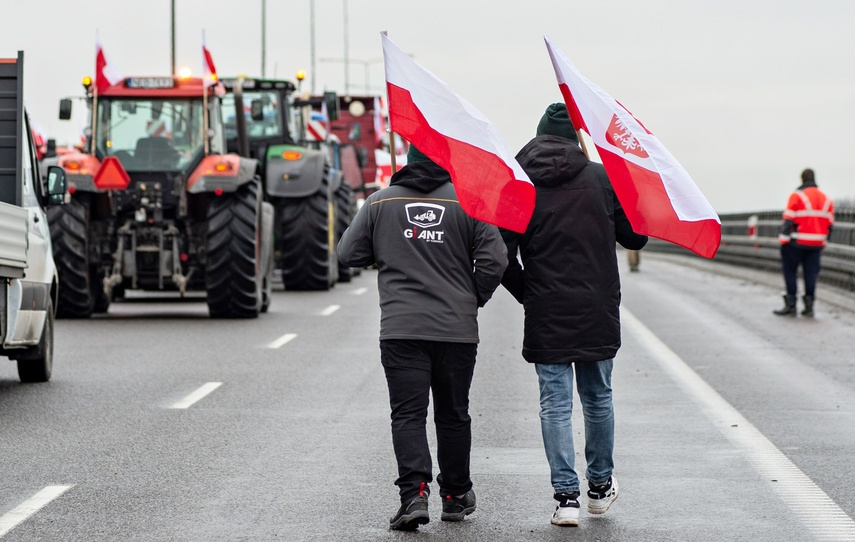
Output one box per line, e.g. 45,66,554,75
502,136,647,363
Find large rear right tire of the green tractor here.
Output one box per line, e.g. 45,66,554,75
276,183,338,290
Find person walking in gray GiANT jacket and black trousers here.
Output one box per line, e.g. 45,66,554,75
338,146,508,530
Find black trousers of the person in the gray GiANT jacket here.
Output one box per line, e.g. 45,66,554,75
380,340,478,502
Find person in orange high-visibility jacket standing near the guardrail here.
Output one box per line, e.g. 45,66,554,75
772,169,834,317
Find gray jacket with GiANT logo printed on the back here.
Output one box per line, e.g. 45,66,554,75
338,162,507,343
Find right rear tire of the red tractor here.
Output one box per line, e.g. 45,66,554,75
205,181,263,318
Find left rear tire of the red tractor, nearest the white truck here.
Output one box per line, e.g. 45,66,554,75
48,194,105,318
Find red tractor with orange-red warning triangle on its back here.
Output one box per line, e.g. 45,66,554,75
49,77,273,318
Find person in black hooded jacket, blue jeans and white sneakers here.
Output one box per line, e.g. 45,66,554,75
502,103,647,525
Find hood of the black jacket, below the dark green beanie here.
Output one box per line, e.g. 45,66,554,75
516,135,589,186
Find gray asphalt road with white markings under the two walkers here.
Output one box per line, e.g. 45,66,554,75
0,254,855,542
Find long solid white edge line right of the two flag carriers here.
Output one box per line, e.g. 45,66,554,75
621,307,855,542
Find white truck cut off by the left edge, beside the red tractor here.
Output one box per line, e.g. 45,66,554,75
0,51,66,382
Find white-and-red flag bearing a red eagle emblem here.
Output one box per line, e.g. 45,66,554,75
544,37,721,258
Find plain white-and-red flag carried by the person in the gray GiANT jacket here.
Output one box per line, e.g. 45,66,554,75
381,33,535,233
